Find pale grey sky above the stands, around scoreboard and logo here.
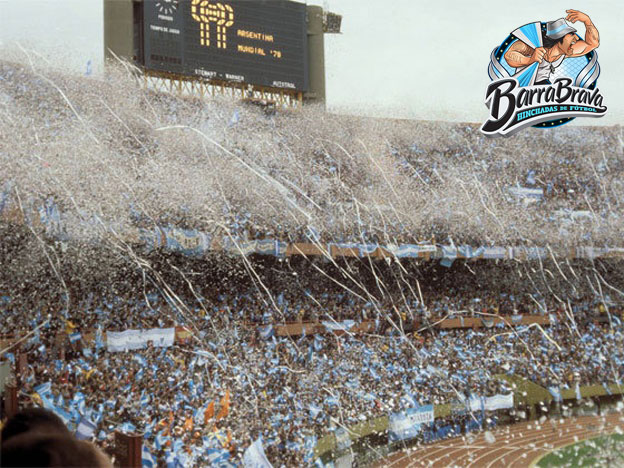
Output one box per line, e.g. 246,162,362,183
0,0,624,125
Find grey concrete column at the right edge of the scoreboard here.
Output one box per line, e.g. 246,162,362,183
305,5,325,104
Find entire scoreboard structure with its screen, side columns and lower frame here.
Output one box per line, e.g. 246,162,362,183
103,0,342,106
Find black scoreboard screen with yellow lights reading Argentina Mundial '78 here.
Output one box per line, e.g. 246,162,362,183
143,0,308,91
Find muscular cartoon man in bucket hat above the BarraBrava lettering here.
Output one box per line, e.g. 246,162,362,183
505,10,600,85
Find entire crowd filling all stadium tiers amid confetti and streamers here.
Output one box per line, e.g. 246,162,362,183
0,56,624,466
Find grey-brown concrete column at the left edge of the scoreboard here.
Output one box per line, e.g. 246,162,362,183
103,0,143,64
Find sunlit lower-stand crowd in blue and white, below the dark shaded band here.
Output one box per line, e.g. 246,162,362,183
0,284,624,466
